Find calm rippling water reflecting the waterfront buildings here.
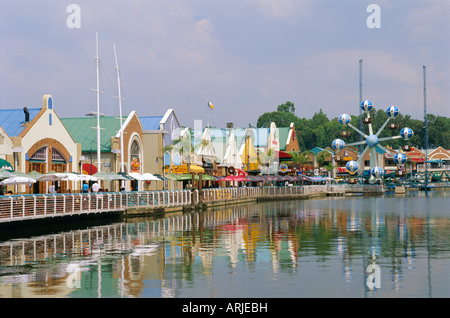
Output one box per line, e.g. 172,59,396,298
0,190,450,298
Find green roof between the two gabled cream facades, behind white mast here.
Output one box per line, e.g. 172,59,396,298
61,117,120,152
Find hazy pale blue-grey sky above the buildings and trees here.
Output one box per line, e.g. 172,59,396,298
0,0,450,128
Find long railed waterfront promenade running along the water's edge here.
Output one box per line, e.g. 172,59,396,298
0,185,383,224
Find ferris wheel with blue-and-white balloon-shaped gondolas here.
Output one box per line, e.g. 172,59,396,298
332,100,414,180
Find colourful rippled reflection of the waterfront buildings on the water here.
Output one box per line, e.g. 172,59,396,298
0,198,450,297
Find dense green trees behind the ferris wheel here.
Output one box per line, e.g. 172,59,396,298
257,101,450,150
